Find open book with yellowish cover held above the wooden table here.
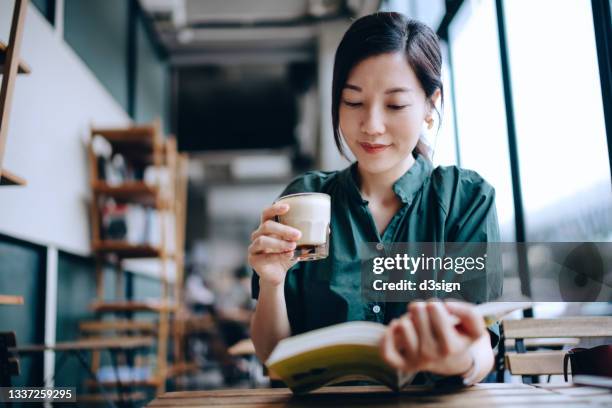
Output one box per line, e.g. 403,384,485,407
266,302,532,394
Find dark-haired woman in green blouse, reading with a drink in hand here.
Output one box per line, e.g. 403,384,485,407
248,12,499,383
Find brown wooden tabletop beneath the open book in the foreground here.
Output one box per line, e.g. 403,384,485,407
148,383,612,408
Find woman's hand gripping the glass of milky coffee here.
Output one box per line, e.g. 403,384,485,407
248,203,302,286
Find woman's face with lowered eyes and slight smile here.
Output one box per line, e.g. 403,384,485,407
339,53,430,173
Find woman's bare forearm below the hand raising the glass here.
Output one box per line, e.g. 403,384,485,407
251,280,291,362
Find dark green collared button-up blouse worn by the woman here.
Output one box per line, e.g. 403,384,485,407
252,155,502,345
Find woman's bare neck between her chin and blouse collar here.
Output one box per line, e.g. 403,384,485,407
357,154,415,202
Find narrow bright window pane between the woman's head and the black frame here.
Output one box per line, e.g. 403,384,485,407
449,0,516,242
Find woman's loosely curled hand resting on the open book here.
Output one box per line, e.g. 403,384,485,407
380,301,486,375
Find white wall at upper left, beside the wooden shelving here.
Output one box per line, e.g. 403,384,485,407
0,0,129,255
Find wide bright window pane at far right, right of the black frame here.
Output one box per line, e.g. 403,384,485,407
504,0,612,241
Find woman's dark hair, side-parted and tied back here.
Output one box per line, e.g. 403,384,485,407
332,12,444,159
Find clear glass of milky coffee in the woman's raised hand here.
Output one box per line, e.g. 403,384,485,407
276,193,331,261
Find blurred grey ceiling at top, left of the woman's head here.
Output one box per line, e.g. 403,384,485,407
140,0,382,66
